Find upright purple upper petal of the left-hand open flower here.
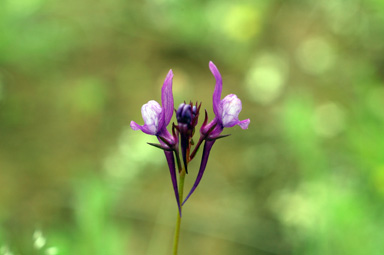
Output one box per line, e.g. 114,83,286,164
159,69,174,129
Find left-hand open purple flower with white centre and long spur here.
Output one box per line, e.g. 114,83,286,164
131,70,181,213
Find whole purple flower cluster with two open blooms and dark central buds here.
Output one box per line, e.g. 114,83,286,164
131,62,250,214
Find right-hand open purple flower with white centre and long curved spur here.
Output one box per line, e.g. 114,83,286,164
183,61,250,204
